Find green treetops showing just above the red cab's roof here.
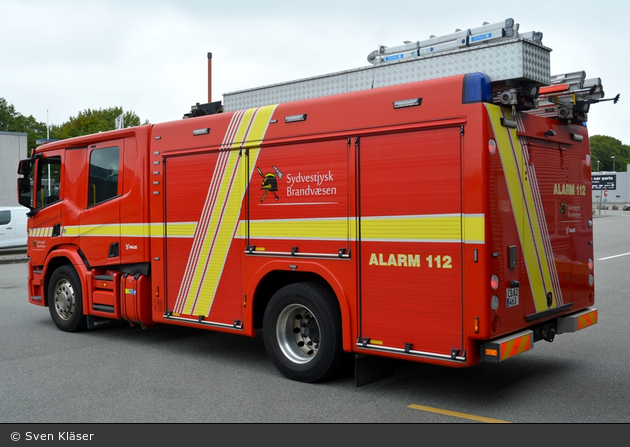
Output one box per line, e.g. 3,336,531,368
50,107,148,140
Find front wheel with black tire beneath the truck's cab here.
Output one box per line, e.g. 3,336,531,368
47,265,87,332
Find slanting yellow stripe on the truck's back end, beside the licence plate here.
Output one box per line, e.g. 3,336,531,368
486,104,557,312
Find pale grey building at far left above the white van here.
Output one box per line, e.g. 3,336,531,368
0,132,28,206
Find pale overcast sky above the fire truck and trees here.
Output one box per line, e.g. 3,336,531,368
0,0,630,144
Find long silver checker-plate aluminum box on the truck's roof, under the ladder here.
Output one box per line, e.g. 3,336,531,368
223,38,551,112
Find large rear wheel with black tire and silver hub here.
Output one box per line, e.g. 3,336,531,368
263,282,344,382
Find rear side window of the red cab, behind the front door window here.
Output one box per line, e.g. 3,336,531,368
88,146,120,207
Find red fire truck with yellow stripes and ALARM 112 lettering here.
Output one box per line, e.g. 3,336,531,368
18,19,603,382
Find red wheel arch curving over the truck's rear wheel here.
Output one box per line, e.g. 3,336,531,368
246,261,352,352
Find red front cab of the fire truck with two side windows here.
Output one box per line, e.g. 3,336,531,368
18,125,151,328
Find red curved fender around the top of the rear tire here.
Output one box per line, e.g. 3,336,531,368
244,259,353,352
